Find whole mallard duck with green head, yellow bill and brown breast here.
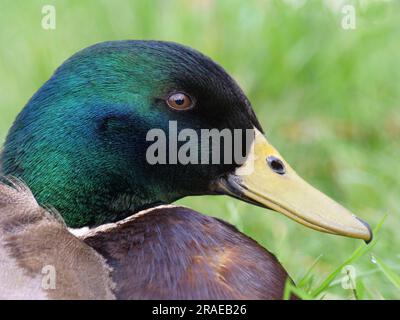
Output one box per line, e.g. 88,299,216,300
0,41,372,299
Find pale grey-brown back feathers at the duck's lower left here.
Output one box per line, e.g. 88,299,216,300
0,180,114,299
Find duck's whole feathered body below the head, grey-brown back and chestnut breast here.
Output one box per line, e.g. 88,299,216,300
0,180,288,299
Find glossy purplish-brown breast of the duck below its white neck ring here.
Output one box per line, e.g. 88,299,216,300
83,206,288,299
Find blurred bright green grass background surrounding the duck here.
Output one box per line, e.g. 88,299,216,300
0,0,400,299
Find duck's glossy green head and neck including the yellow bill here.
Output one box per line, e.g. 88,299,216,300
1,41,372,241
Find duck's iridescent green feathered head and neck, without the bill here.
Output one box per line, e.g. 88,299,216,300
2,41,261,227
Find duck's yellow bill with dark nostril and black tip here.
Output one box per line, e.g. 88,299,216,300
217,129,372,242
